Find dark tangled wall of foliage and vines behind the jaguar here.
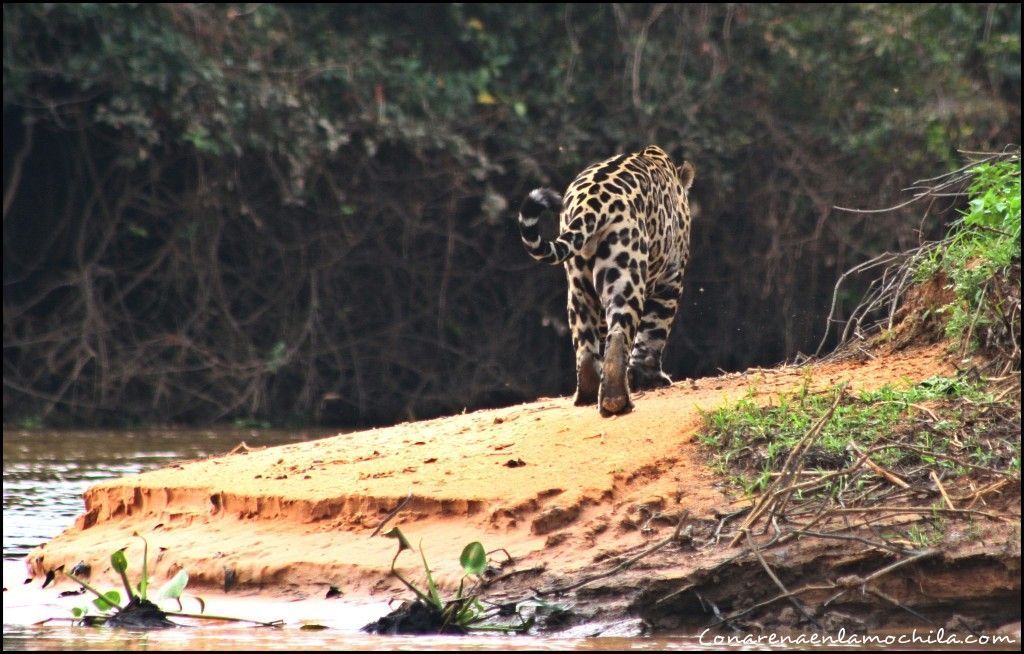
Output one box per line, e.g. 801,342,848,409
3,4,1021,424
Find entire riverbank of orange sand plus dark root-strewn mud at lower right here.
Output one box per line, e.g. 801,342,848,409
19,345,1020,630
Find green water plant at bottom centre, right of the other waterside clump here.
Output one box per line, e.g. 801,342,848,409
384,527,534,634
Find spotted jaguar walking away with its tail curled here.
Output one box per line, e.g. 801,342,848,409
518,145,696,416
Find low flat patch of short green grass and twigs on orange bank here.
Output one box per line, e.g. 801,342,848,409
698,377,1020,494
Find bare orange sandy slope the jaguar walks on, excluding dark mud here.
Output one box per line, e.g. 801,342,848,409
29,345,952,599
